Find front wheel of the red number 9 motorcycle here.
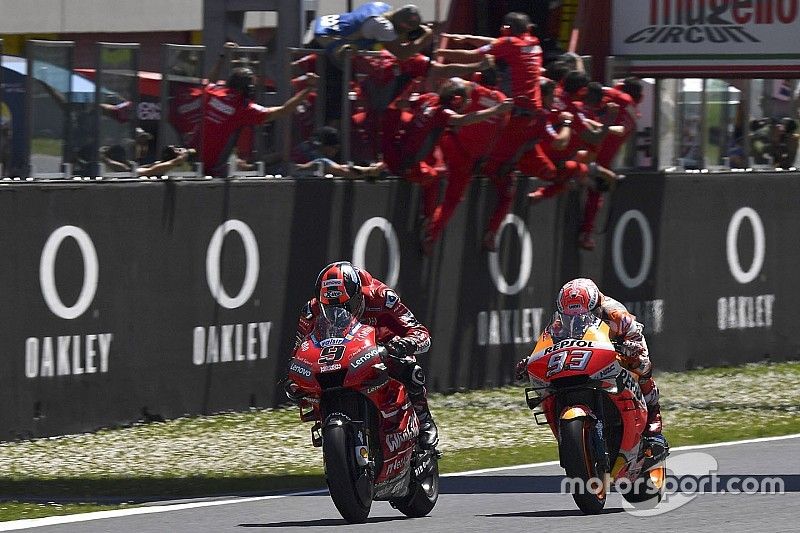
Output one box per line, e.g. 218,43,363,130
322,424,372,524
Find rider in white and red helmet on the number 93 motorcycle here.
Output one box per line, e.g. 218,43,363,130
515,278,668,449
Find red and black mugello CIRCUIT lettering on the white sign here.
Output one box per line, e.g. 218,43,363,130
625,0,800,44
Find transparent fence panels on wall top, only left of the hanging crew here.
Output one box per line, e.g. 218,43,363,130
0,40,390,181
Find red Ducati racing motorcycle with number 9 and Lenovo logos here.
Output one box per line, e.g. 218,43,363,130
284,308,439,523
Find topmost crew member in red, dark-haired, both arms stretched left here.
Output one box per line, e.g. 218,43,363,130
437,12,542,251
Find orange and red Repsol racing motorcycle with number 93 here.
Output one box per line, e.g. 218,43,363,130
525,313,668,514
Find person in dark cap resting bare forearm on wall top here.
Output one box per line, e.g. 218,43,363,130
292,126,384,178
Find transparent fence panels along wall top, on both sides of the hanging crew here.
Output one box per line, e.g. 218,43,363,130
0,40,800,180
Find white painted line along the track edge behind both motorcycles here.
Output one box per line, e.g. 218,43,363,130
0,433,800,531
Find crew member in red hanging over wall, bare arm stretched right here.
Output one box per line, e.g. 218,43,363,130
382,83,511,224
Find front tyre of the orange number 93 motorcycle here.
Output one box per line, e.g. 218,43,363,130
558,418,606,514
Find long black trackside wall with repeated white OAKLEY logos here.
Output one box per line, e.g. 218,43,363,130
0,174,800,440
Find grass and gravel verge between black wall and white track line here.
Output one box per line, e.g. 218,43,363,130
0,363,800,521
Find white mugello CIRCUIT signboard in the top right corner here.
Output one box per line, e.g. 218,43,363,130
612,0,800,75
